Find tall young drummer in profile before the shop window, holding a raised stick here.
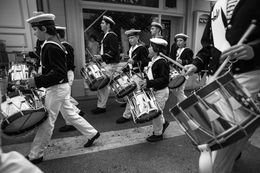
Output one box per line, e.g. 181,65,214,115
92,16,120,114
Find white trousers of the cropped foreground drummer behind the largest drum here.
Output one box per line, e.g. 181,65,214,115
212,70,260,173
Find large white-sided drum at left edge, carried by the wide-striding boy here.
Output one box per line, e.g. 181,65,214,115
1,90,47,136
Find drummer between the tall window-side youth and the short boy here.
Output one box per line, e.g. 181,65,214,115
116,29,150,124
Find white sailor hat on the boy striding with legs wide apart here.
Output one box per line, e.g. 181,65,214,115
26,12,55,27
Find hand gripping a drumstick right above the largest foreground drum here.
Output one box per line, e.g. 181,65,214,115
220,44,254,62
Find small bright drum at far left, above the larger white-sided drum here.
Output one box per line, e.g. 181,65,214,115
8,63,30,81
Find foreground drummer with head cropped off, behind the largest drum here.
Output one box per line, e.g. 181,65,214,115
185,0,260,173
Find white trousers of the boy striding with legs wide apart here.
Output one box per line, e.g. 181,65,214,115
29,83,97,159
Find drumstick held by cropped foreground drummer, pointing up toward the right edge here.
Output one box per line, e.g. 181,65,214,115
210,20,256,81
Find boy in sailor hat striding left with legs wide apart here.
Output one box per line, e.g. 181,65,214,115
26,11,100,164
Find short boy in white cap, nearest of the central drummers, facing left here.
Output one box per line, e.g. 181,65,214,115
140,38,170,142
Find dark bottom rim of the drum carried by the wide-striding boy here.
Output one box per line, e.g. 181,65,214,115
1,107,48,136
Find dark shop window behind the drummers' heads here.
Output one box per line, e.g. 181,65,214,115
83,9,158,61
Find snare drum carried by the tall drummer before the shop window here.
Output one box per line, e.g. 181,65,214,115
80,62,110,91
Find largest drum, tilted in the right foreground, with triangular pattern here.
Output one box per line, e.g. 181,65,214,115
170,73,260,151
